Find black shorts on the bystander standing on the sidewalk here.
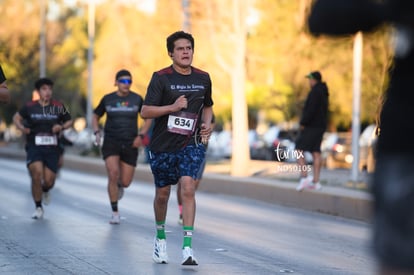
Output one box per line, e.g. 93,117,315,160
296,127,325,152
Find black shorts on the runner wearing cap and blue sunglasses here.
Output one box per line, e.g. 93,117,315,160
102,139,138,167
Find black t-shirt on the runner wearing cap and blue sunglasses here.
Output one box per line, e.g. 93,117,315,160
94,92,143,142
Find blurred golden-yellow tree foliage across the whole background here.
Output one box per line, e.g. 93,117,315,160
0,0,391,147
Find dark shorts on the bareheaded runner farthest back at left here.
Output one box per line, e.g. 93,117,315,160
26,144,60,174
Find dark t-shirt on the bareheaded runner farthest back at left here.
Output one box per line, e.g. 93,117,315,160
19,100,72,145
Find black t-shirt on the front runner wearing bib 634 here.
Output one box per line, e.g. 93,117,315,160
144,66,213,152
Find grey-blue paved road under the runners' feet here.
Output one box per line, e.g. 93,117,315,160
0,159,375,275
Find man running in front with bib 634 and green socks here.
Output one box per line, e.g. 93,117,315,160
142,31,213,265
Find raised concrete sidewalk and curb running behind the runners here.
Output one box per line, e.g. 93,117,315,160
0,146,372,222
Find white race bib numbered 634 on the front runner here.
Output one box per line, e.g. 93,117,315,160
167,111,197,136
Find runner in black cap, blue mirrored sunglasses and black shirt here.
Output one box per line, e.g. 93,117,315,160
92,70,151,224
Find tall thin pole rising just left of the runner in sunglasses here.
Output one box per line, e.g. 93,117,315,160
86,1,95,129
